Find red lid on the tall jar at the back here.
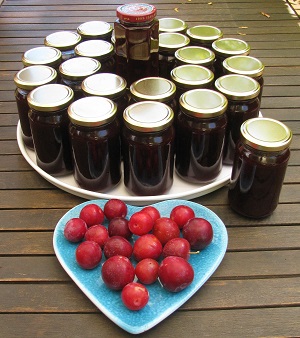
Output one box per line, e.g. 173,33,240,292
117,3,156,23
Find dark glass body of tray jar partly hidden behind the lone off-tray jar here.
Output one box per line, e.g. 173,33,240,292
223,97,260,164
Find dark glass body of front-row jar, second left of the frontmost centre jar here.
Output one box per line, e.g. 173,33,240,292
29,108,73,176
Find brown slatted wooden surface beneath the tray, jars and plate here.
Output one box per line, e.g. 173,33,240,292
0,0,300,338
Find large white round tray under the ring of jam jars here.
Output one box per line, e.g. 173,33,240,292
17,122,232,205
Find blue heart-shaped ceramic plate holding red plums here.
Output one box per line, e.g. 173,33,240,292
53,200,228,334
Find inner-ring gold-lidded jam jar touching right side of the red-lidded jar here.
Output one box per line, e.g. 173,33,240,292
159,33,190,79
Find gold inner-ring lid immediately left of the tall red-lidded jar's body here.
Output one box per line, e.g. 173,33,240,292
74,40,115,62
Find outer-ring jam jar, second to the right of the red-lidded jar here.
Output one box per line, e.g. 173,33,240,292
186,25,223,49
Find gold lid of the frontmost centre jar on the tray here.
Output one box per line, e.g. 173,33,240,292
123,101,174,133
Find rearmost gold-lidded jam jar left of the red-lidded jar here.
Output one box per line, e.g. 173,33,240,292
77,20,113,42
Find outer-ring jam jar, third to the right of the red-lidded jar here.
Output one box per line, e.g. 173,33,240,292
212,38,250,78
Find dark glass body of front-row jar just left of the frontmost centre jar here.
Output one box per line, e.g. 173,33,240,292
69,119,121,191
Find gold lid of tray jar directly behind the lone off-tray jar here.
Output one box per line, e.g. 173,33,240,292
215,74,260,101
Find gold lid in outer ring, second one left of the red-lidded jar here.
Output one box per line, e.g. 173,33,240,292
44,31,81,50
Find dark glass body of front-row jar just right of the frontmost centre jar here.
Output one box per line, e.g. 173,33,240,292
175,111,227,183
